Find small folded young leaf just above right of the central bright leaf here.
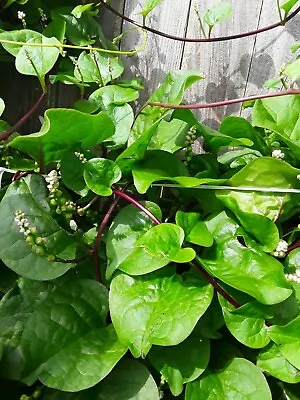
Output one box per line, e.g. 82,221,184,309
176,211,214,247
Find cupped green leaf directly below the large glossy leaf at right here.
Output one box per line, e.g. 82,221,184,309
218,296,270,349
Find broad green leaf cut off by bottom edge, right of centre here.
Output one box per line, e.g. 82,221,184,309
185,358,272,400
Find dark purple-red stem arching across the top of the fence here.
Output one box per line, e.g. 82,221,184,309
99,0,300,43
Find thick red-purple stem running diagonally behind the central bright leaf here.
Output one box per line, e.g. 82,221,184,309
114,190,240,308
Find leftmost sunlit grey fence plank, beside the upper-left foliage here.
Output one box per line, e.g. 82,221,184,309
122,0,190,102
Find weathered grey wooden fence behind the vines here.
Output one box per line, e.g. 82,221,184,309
0,0,300,131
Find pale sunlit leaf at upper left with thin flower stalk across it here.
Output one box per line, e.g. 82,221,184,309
74,51,124,86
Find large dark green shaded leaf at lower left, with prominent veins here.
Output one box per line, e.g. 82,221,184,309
21,279,126,392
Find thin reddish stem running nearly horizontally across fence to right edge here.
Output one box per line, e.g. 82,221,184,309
146,89,300,110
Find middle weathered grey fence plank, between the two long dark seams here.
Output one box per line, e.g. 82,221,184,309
182,0,262,126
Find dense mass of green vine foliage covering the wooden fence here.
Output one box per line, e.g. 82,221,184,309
0,0,300,400
